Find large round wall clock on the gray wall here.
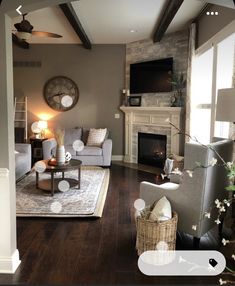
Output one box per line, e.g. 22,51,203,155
43,76,79,111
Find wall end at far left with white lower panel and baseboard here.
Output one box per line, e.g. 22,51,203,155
0,12,20,273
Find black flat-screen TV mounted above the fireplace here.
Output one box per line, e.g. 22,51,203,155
130,58,173,94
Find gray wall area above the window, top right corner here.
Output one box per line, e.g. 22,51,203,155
197,5,235,47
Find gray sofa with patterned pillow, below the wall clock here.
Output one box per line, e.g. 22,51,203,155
42,128,112,166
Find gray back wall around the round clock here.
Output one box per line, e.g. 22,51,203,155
14,45,125,155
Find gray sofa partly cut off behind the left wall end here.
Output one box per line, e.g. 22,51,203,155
15,143,32,180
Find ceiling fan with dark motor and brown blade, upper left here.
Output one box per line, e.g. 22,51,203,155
12,14,62,49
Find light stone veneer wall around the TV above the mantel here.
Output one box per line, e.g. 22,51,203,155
126,30,189,106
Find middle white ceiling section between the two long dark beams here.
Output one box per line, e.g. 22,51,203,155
72,0,166,44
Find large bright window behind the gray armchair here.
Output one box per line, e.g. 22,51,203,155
190,30,235,144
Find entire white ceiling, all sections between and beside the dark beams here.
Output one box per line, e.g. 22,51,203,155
13,0,204,44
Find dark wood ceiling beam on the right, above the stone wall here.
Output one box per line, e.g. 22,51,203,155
153,0,184,42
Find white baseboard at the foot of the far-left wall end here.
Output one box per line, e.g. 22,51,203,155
0,249,21,274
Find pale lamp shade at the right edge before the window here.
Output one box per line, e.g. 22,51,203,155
216,88,235,122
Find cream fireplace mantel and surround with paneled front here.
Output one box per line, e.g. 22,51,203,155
120,106,183,163
